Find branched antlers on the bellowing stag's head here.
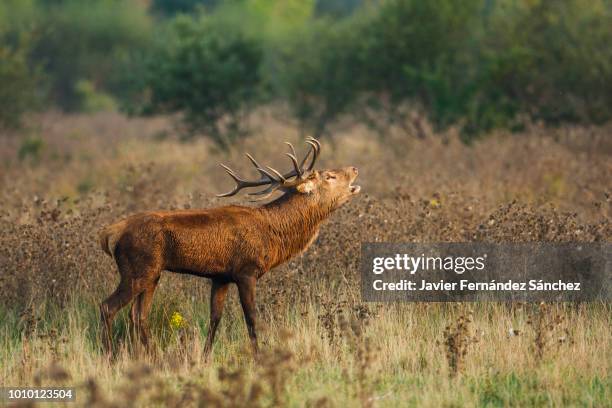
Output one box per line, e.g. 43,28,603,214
217,137,321,200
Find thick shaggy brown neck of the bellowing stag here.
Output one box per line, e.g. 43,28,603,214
260,193,332,265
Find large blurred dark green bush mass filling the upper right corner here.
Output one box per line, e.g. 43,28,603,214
354,0,612,140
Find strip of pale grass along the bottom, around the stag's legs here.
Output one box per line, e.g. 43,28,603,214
0,294,612,407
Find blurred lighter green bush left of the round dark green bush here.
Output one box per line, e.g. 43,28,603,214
34,0,153,110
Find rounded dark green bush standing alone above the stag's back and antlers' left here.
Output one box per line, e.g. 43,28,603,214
144,16,263,147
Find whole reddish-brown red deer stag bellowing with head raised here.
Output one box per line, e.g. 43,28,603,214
100,138,360,357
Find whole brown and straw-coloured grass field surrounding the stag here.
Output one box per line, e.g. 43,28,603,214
0,112,612,407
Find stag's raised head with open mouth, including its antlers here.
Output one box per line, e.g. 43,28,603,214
217,138,361,208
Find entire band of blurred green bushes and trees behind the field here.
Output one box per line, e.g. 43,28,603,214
0,0,612,146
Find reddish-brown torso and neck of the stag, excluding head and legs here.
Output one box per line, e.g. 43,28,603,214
101,196,328,280
